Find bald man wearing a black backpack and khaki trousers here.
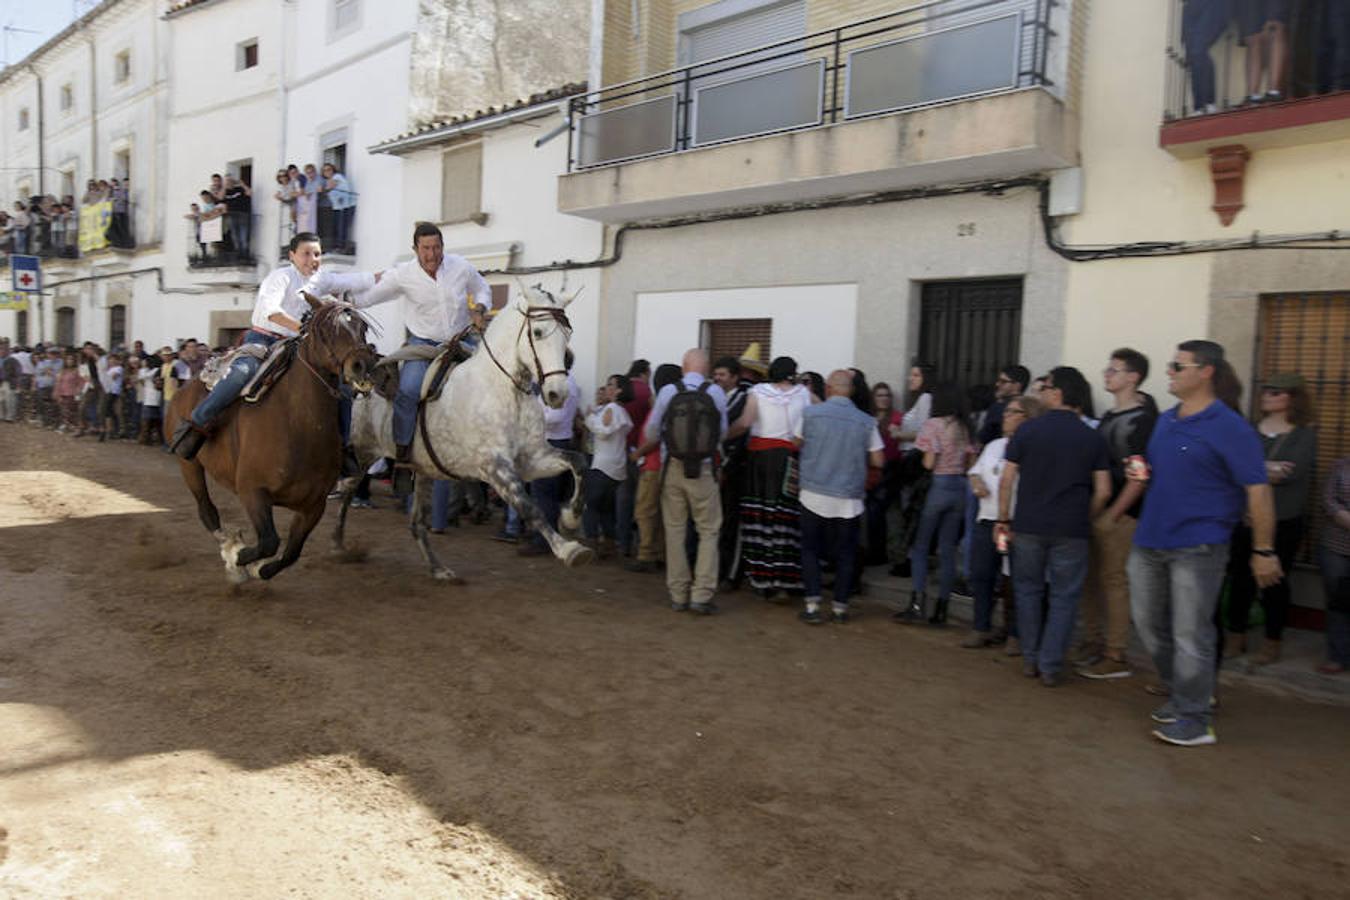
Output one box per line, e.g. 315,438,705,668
637,348,726,615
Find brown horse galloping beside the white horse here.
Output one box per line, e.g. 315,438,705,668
165,294,375,583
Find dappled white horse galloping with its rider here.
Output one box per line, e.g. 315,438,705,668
333,285,591,583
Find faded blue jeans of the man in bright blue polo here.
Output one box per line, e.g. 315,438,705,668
1126,544,1229,722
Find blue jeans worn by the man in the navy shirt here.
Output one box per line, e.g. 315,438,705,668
1013,532,1091,675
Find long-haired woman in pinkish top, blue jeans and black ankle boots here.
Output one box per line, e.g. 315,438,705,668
895,382,971,625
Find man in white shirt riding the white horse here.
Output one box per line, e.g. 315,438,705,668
356,221,491,495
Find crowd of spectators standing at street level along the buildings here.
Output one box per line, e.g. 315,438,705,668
0,330,1350,745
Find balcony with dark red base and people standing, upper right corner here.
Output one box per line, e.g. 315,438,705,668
1158,0,1350,159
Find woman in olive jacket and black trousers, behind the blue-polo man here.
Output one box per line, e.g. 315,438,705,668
1215,372,1318,665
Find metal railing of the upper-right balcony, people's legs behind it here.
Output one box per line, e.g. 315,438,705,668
1162,0,1350,121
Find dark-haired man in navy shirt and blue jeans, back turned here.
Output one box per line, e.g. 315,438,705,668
994,366,1111,687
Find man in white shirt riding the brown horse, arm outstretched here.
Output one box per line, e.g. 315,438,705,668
169,231,379,464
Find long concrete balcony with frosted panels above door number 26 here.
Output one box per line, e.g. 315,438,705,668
559,0,1077,223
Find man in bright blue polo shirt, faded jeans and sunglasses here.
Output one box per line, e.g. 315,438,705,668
1127,340,1284,746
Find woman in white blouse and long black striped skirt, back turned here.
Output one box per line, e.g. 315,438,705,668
728,356,811,598
